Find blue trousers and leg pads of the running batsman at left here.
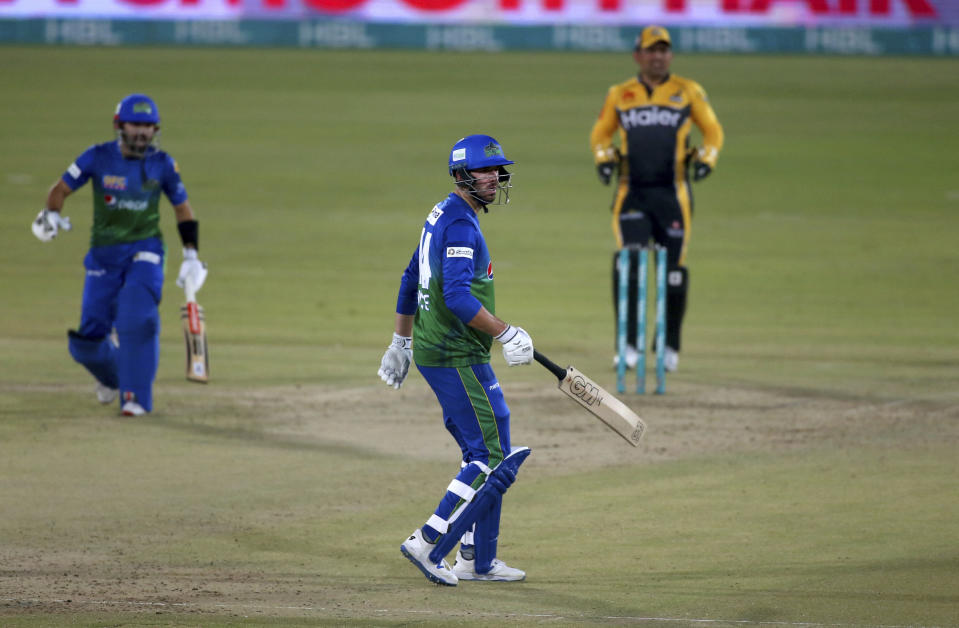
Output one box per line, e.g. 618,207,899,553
70,238,166,412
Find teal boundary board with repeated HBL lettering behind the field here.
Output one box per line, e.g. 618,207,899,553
0,19,959,56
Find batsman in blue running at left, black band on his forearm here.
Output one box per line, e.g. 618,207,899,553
33,94,207,416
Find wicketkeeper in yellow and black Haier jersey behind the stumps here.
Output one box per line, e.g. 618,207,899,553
589,26,723,371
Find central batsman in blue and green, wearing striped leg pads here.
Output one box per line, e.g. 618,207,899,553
378,135,533,586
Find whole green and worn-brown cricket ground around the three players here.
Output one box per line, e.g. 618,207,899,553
0,47,959,628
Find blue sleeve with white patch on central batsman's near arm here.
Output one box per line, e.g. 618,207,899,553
440,220,483,324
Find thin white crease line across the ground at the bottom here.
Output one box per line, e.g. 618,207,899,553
0,598,944,628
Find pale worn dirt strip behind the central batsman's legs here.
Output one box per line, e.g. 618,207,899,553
229,381,959,472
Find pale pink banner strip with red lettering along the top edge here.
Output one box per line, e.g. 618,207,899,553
0,0,959,28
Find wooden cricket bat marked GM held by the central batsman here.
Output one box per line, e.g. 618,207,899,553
533,349,646,447
